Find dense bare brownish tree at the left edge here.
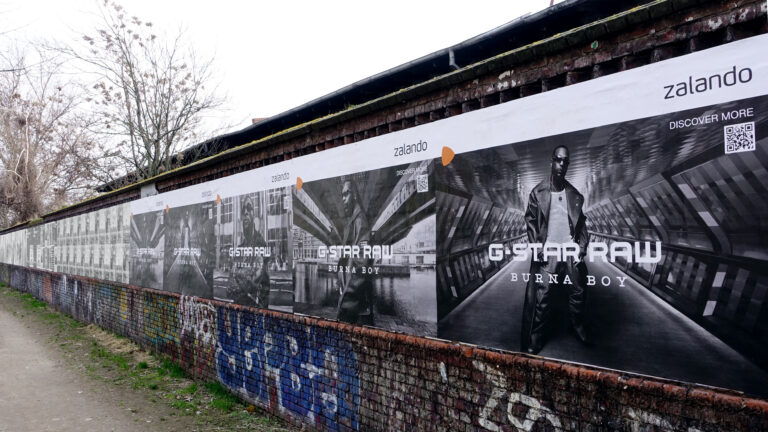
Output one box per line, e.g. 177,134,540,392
0,51,98,226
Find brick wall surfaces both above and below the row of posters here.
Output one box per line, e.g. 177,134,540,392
0,0,768,432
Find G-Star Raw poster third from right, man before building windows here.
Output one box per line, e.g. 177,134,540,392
213,187,293,312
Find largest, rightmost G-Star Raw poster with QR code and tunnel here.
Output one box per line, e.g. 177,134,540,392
436,97,768,395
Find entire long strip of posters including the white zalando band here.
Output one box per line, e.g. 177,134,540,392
0,36,768,396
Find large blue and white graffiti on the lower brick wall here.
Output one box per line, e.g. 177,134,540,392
216,307,360,430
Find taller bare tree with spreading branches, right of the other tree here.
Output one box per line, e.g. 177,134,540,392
69,0,223,181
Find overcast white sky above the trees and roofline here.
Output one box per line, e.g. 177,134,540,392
0,0,559,129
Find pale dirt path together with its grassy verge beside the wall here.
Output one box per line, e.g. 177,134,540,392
0,285,298,432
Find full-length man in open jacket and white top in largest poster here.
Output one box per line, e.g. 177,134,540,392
521,145,589,354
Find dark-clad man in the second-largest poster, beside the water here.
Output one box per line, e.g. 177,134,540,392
337,178,373,325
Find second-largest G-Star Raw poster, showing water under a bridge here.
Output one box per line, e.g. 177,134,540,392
293,161,437,335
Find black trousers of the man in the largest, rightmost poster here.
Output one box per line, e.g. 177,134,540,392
531,258,587,337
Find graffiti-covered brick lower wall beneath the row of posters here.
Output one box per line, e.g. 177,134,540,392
0,264,768,432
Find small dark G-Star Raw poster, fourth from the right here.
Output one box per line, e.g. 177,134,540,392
163,201,217,298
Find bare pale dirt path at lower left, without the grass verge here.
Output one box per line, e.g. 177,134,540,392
0,308,149,432
